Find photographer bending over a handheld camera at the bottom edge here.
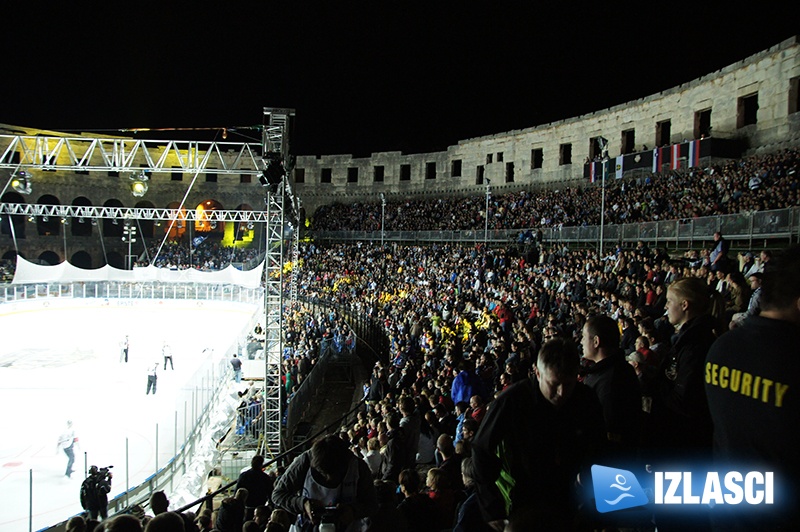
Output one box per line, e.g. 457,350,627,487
272,436,378,532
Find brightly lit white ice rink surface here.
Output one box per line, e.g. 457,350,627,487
0,299,257,532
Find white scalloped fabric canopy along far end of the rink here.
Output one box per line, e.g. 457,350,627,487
12,255,264,288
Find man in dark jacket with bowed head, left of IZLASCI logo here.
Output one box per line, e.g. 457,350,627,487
472,338,605,528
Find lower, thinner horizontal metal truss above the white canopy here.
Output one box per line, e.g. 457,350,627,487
0,203,269,223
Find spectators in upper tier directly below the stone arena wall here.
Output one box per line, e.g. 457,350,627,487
313,149,800,231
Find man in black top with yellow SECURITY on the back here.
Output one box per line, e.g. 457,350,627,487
704,247,800,530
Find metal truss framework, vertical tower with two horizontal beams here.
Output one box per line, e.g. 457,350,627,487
0,113,296,456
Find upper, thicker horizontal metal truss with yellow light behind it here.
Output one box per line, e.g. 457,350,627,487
0,133,264,175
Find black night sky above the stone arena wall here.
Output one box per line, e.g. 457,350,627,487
0,1,800,156
